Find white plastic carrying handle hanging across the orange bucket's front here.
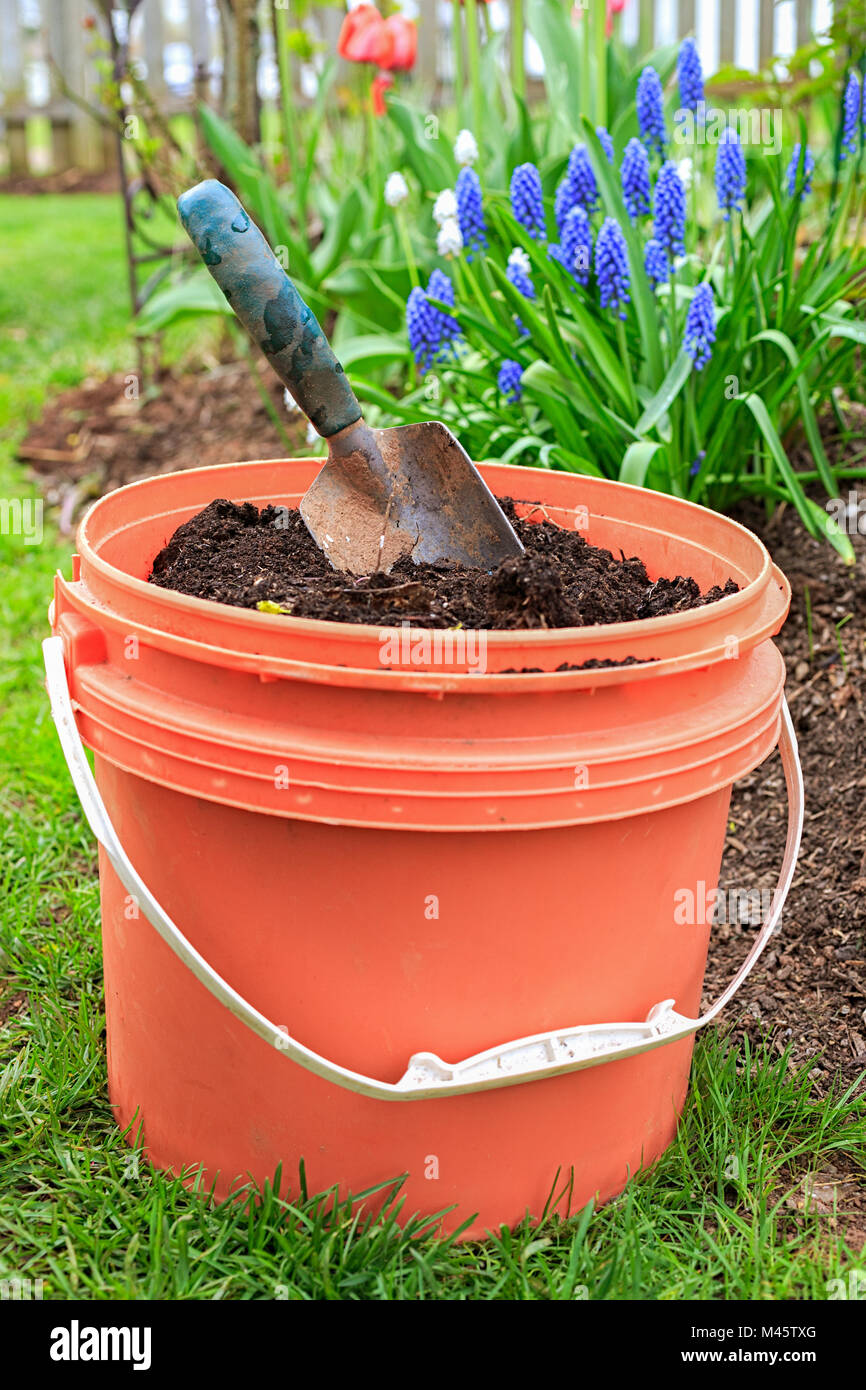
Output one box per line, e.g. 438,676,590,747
42,637,803,1101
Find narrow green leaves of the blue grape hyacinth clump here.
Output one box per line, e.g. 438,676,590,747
378,96,866,562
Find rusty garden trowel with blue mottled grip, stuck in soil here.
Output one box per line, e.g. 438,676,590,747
178,179,523,574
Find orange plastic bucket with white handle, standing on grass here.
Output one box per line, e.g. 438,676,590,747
46,460,801,1233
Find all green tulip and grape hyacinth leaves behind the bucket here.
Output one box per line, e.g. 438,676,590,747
140,0,866,560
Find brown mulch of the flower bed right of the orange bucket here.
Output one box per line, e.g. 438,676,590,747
705,494,866,1100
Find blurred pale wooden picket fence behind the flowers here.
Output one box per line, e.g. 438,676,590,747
0,0,831,177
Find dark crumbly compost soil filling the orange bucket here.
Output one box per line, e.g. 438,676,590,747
150,499,737,630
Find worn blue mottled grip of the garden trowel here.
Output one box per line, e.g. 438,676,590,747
178,178,361,439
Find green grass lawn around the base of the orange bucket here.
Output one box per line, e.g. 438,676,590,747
0,196,866,1300
